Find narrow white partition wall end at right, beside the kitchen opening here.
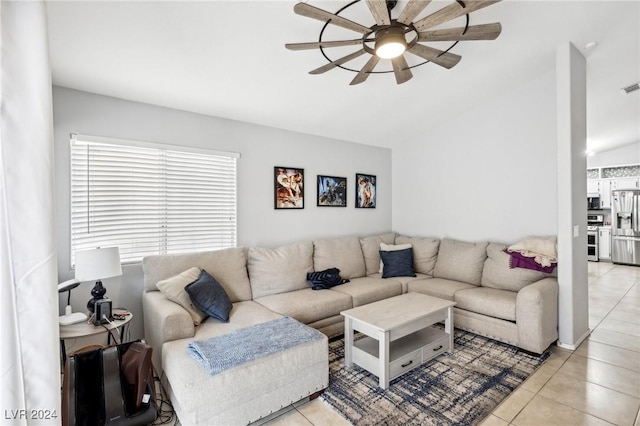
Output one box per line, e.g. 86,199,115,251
556,43,589,350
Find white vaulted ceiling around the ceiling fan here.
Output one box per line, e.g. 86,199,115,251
47,0,640,151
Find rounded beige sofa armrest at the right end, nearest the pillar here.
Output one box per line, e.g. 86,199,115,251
516,278,558,354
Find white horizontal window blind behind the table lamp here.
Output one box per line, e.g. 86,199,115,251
71,134,238,265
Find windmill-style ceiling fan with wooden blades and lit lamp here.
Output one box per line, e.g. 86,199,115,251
285,0,502,85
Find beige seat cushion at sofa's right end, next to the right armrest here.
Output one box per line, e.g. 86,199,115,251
454,287,518,321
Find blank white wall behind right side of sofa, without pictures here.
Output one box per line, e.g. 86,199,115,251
393,70,557,243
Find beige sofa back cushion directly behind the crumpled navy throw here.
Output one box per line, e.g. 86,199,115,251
313,237,366,279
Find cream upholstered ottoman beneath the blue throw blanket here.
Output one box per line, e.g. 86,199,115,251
162,318,329,426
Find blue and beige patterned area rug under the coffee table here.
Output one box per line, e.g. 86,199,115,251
321,329,550,426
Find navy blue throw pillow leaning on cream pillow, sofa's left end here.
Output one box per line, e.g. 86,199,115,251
184,269,233,322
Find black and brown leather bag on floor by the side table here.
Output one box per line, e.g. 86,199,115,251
62,342,157,426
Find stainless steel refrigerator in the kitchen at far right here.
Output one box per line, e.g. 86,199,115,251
611,189,640,265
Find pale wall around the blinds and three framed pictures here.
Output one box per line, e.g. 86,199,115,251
53,87,391,337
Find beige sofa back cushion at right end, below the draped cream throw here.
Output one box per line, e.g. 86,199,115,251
481,243,550,291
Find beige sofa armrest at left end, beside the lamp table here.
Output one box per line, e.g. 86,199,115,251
142,291,195,374
